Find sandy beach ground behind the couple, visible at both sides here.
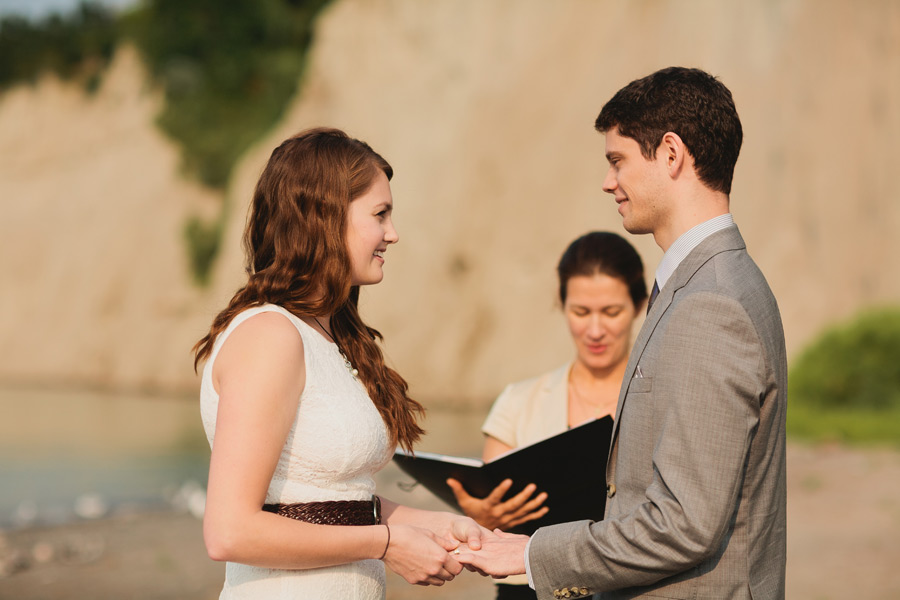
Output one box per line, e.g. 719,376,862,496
0,444,900,600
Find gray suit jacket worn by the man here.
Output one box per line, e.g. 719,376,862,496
529,227,787,600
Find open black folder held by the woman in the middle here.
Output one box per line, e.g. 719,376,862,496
394,417,613,535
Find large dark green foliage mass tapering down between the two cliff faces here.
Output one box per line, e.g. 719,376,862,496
125,0,327,188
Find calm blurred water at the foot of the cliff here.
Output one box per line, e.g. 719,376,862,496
0,389,484,528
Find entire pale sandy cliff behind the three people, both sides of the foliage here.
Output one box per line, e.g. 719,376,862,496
0,0,900,402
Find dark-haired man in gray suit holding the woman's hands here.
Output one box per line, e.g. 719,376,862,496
460,68,787,600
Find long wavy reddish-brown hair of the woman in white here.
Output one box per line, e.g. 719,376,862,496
193,128,424,450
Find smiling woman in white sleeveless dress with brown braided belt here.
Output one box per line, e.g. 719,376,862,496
194,128,489,600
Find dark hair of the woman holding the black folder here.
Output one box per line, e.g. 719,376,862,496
556,231,647,310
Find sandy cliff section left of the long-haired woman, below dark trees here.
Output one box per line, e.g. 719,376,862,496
0,48,219,389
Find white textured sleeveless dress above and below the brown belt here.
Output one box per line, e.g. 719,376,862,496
200,304,394,600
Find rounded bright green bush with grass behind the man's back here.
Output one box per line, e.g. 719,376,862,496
788,308,900,444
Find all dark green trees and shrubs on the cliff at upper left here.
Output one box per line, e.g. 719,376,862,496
0,0,329,285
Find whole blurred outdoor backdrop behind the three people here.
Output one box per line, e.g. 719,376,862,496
0,0,900,600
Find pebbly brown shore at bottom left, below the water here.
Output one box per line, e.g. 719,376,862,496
0,510,225,600
